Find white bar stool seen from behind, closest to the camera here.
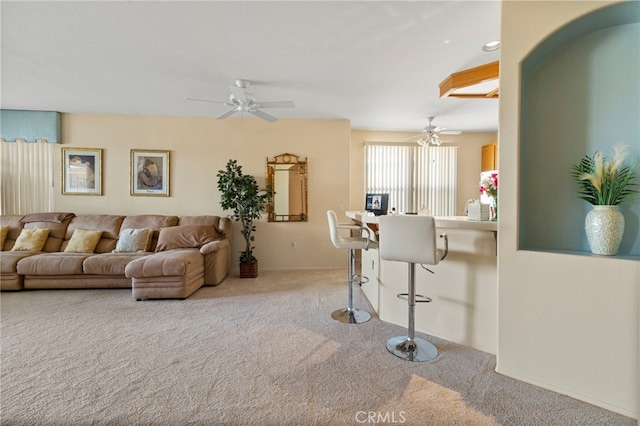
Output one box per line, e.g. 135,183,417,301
378,215,449,361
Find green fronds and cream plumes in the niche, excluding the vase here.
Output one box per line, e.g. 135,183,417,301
571,145,638,206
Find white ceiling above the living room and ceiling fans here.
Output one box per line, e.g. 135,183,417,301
0,0,500,132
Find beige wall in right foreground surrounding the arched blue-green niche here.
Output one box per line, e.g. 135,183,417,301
497,1,640,418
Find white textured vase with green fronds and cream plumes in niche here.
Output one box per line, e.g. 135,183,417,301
571,145,638,256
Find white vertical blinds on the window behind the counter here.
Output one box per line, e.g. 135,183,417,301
365,143,458,216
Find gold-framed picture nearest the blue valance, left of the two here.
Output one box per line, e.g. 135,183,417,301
62,148,102,195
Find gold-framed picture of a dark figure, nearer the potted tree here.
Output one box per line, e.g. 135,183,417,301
130,149,169,197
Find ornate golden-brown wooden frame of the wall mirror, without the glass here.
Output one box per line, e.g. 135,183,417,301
267,153,309,222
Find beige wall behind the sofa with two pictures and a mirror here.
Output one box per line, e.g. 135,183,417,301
54,114,351,269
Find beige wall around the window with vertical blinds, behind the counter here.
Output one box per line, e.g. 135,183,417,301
349,129,497,215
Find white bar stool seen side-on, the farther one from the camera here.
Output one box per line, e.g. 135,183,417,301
327,210,378,324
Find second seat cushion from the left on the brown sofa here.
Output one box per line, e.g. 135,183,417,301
16,253,90,275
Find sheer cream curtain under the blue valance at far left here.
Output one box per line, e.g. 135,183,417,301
0,141,59,214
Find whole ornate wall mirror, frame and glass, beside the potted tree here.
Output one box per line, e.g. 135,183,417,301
267,153,307,222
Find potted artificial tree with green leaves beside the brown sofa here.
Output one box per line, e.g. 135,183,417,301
217,160,273,278
